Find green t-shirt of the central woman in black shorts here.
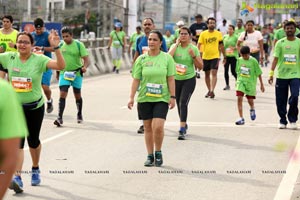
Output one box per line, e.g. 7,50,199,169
132,51,175,103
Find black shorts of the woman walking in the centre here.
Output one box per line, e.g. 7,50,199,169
138,101,169,120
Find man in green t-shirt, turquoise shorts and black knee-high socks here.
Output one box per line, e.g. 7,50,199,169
54,27,89,127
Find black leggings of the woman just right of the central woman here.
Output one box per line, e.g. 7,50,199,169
175,77,196,122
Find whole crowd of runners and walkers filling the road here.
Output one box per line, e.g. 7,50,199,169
0,14,300,199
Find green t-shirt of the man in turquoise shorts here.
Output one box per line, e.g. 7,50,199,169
60,40,89,76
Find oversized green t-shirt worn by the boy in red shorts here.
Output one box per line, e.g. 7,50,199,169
236,56,262,96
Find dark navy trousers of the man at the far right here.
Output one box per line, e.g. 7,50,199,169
275,78,299,125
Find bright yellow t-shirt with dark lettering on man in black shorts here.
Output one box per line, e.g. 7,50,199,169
198,30,223,60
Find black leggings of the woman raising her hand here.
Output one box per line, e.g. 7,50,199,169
20,105,45,149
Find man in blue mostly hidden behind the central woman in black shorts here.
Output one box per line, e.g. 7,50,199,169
133,17,168,134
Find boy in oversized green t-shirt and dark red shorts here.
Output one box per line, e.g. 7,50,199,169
235,46,265,125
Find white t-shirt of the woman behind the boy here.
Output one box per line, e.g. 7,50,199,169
238,31,263,53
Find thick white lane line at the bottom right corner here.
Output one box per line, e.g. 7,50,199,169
274,134,300,200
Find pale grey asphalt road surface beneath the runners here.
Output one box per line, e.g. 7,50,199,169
5,63,300,200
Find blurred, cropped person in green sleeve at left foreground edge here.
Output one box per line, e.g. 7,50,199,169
0,79,28,199
